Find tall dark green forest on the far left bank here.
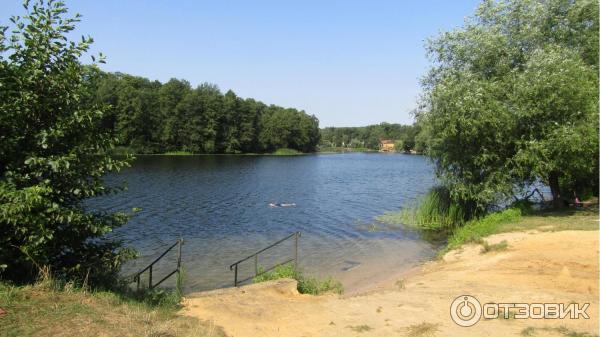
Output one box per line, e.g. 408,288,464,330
88,69,319,153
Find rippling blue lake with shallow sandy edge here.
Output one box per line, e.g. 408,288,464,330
88,153,436,292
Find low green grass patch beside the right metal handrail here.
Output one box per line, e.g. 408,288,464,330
252,264,344,295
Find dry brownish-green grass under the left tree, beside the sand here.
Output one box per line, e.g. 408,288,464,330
0,281,225,336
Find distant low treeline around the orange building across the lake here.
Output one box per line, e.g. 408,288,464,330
319,123,422,152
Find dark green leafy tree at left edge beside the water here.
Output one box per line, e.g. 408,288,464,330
0,0,133,285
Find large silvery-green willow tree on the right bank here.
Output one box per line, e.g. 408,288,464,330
417,0,598,211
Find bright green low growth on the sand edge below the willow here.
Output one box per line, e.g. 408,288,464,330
447,208,521,249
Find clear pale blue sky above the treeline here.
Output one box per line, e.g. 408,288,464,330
0,0,479,126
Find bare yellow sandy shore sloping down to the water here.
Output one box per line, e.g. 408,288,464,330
183,231,599,337
